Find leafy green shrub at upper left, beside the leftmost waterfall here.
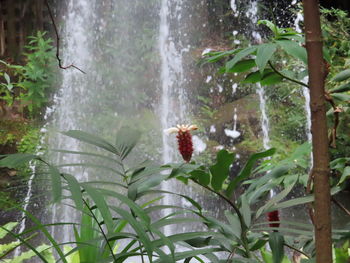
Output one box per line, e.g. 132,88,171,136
0,31,54,115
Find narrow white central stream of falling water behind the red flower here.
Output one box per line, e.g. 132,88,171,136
159,0,188,235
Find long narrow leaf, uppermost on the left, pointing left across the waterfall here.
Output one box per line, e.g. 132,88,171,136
63,130,120,155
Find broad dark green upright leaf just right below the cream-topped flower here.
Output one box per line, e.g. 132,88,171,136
209,150,235,191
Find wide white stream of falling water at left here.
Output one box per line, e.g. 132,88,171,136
49,0,94,241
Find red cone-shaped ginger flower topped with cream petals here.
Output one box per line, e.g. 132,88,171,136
165,124,198,163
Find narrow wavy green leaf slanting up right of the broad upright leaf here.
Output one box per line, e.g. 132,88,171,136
226,148,276,198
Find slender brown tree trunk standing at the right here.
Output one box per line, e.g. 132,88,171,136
303,0,332,263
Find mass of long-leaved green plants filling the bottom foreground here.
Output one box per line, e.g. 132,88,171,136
0,128,346,263
